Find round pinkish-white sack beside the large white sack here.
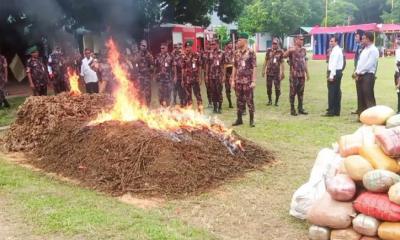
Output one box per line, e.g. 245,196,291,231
326,174,356,202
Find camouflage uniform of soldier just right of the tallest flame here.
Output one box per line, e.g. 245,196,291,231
135,51,154,106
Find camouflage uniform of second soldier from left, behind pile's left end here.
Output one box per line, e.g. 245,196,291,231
26,58,49,96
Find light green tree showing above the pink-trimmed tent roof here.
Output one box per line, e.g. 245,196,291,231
321,0,358,26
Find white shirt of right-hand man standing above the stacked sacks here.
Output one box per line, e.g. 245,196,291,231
356,44,379,74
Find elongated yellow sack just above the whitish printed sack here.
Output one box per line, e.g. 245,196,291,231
360,146,400,173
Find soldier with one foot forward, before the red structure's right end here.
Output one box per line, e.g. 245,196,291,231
182,40,203,112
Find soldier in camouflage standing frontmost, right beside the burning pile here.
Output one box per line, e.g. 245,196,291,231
232,33,257,127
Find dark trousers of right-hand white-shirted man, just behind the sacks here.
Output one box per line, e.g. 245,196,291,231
358,73,376,114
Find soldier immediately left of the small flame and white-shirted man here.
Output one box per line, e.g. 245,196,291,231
47,47,67,94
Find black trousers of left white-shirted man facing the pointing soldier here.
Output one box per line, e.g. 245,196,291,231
328,70,343,115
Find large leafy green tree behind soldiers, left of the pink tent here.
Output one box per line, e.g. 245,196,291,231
239,0,310,39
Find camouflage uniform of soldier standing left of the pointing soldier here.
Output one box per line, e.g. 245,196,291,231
265,48,284,104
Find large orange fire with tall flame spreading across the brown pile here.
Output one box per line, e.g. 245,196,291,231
89,40,243,153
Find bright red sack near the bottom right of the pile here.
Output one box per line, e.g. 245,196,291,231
354,192,400,222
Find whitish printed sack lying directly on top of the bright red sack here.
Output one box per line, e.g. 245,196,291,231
363,170,400,192
